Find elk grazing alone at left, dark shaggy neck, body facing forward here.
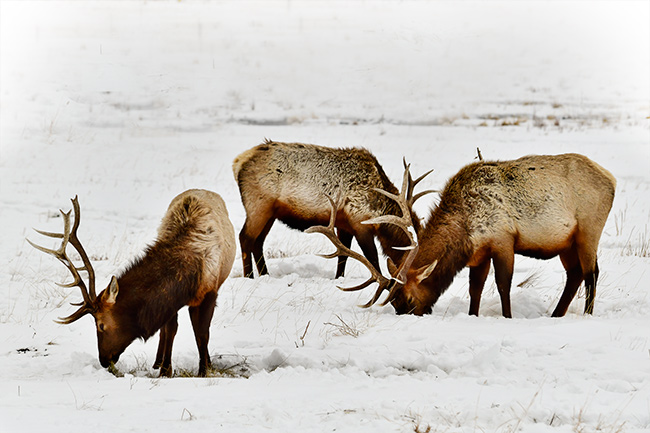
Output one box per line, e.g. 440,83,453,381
28,189,236,377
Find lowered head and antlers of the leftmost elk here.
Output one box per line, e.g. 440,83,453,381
27,196,137,367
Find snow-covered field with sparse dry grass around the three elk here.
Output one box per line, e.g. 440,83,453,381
0,0,650,433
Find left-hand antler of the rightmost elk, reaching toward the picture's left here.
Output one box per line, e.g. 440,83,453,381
305,196,392,307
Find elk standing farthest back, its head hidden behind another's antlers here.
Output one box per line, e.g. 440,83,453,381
233,140,429,278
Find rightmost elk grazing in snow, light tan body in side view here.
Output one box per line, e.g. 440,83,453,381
310,154,616,317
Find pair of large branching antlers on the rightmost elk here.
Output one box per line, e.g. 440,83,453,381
306,160,433,308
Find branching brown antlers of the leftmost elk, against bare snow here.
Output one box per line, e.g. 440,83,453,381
27,196,97,325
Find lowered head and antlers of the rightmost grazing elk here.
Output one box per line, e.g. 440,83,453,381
305,160,437,315
